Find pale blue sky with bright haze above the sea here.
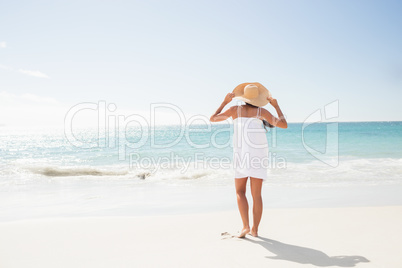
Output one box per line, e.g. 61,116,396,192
0,0,402,124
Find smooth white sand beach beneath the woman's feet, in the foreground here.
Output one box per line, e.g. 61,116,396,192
0,206,402,268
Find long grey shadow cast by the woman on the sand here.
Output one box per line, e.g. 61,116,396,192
246,237,370,267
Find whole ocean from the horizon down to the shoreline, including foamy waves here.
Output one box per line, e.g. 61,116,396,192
0,122,402,221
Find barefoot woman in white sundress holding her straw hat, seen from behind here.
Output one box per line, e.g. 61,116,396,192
210,82,287,238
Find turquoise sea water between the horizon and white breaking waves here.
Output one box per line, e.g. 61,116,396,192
0,122,402,182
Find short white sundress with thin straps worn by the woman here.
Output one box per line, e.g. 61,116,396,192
233,106,269,180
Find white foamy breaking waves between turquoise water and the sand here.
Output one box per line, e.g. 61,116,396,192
0,158,402,187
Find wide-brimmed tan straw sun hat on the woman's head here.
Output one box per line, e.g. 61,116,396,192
233,82,272,107
